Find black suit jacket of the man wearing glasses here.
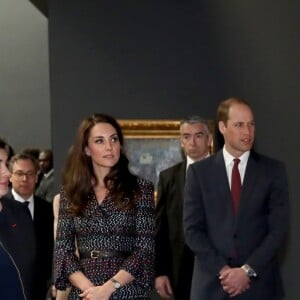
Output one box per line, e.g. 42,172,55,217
7,191,54,300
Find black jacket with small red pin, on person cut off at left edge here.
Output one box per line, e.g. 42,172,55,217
0,196,36,300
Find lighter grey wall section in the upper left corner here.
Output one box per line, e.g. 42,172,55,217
0,0,52,151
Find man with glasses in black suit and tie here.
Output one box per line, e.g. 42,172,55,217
7,153,53,300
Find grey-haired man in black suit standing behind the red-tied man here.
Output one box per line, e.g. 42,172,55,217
155,116,212,300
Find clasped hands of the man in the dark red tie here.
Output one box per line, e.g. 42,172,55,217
219,268,250,297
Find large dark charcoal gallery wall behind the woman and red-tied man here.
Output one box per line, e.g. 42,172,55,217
49,0,300,300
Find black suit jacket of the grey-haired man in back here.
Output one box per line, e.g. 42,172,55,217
155,161,194,299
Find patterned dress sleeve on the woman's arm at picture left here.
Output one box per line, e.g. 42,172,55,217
53,189,80,290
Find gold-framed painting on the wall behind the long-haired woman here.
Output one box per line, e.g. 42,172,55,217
118,120,183,189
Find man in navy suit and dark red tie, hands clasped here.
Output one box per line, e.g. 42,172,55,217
183,98,288,300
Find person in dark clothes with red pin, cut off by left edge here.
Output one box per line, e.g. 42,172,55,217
0,138,36,300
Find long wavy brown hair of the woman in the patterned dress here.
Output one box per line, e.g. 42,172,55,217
62,114,139,215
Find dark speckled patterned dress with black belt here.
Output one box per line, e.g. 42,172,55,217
54,178,155,300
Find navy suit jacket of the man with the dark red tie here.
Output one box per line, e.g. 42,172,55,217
184,151,288,300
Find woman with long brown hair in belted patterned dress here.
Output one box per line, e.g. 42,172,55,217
54,114,155,300
